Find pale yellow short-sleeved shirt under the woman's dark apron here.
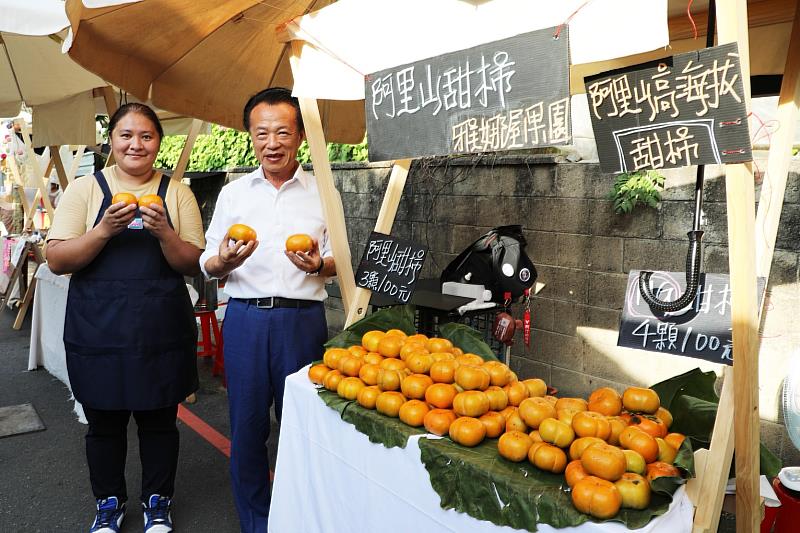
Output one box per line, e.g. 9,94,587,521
47,166,205,250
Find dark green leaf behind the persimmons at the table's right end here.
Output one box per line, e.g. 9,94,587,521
651,368,781,477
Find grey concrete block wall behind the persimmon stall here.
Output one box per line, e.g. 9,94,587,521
222,155,800,464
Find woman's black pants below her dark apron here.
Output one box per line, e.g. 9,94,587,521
83,405,180,502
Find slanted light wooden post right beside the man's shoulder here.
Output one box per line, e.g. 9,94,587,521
289,41,356,309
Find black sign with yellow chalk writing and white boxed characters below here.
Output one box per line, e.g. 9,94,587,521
586,43,753,172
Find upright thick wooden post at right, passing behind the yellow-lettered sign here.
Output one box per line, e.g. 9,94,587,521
706,0,761,533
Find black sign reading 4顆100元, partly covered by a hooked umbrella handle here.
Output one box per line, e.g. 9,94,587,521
617,270,765,365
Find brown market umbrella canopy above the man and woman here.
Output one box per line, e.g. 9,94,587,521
65,0,364,143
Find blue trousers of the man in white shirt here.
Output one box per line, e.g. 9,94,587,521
223,299,328,533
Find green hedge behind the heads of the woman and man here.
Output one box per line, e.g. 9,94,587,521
156,125,367,171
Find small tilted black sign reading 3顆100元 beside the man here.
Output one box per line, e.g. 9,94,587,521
356,231,428,304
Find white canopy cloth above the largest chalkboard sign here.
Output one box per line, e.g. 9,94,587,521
286,0,669,100
